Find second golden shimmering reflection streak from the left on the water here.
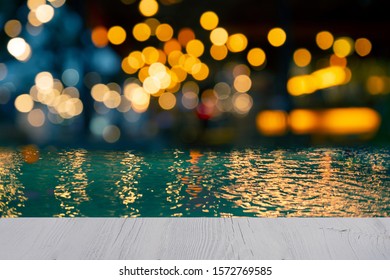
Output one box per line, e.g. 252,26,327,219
54,149,92,217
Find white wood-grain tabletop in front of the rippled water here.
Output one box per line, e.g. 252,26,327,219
0,218,390,260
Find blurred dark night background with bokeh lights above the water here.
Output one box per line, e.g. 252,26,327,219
0,0,390,149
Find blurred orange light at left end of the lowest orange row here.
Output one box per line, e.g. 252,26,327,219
256,110,287,136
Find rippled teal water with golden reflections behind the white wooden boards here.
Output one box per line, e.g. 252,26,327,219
0,148,390,217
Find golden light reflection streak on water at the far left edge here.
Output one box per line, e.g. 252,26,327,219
0,149,27,218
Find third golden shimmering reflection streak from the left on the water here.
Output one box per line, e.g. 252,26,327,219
115,152,143,217
